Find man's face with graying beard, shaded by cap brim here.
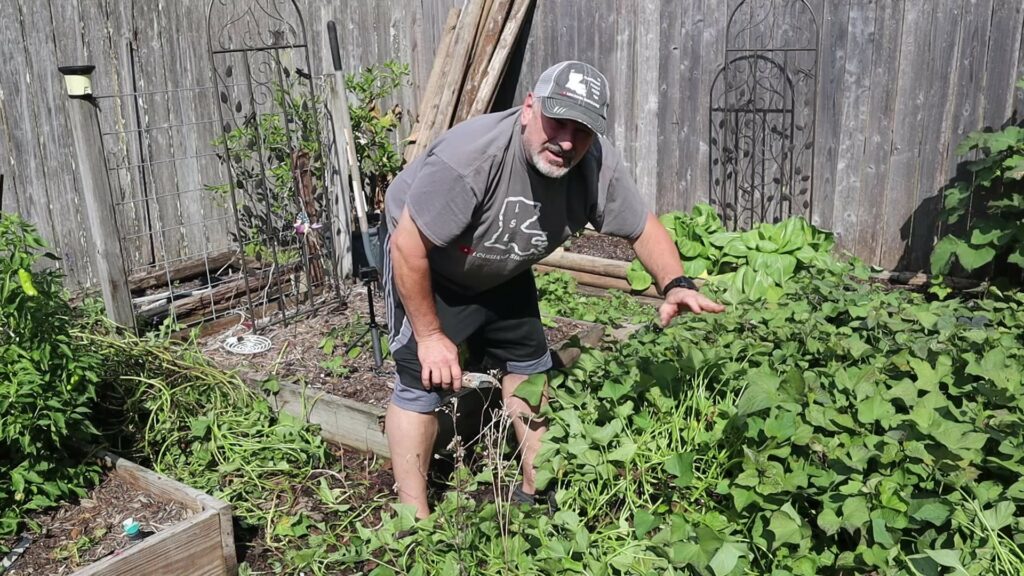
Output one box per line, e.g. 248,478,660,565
519,94,594,178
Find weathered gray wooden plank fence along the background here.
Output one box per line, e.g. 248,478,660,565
0,0,1024,284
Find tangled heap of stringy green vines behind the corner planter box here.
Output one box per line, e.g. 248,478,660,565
91,330,327,526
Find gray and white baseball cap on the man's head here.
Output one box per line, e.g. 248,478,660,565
534,60,608,135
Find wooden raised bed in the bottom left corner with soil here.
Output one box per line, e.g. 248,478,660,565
5,453,238,576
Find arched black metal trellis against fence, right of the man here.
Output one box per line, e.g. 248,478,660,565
709,0,820,230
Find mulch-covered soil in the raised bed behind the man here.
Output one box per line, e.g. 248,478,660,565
200,286,585,407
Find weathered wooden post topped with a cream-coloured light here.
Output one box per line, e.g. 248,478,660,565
58,66,135,329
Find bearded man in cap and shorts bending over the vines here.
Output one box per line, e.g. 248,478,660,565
383,61,724,518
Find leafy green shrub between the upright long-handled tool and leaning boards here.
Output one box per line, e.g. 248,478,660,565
345,60,410,210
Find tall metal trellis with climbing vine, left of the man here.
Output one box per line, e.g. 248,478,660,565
207,0,341,321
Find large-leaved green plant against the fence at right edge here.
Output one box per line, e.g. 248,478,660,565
931,97,1024,276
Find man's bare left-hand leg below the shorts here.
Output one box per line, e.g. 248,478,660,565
384,402,437,519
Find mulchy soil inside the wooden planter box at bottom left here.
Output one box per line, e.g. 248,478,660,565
5,474,191,576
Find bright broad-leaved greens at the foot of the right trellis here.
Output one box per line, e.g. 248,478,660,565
628,204,840,303
